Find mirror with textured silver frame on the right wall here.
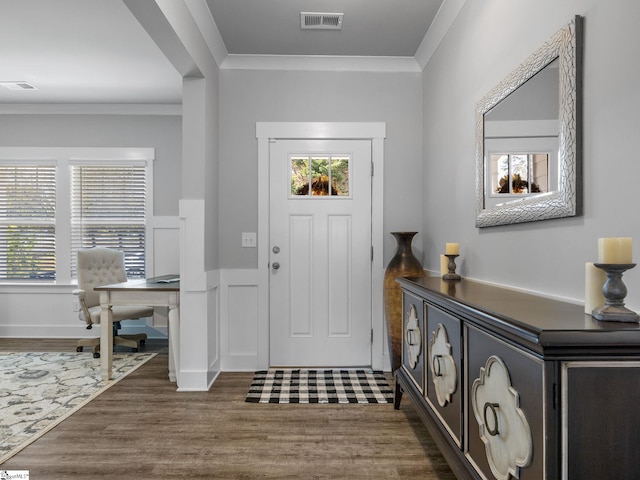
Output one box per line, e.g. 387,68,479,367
476,16,582,227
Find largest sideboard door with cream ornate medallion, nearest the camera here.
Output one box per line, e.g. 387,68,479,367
465,326,553,480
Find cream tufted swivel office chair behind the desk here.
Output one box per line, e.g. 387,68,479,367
73,248,153,357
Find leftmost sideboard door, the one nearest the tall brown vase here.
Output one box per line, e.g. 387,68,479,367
402,292,424,393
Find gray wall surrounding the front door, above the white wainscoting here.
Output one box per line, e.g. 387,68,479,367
219,69,422,268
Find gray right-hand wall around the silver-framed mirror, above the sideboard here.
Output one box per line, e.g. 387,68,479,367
422,0,640,310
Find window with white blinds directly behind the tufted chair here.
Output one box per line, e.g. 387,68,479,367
71,165,147,278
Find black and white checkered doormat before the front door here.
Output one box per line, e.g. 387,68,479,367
246,369,393,403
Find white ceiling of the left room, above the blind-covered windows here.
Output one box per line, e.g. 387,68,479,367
0,0,181,103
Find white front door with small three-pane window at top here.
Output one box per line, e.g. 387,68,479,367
269,140,372,367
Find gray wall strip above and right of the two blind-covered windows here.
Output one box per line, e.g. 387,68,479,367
0,115,182,216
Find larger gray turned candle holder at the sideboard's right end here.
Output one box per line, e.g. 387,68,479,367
591,263,640,322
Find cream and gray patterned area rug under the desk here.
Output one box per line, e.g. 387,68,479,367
0,352,156,464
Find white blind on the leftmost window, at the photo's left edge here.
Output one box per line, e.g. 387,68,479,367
0,162,56,280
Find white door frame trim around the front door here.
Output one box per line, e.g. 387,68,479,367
256,122,389,370
